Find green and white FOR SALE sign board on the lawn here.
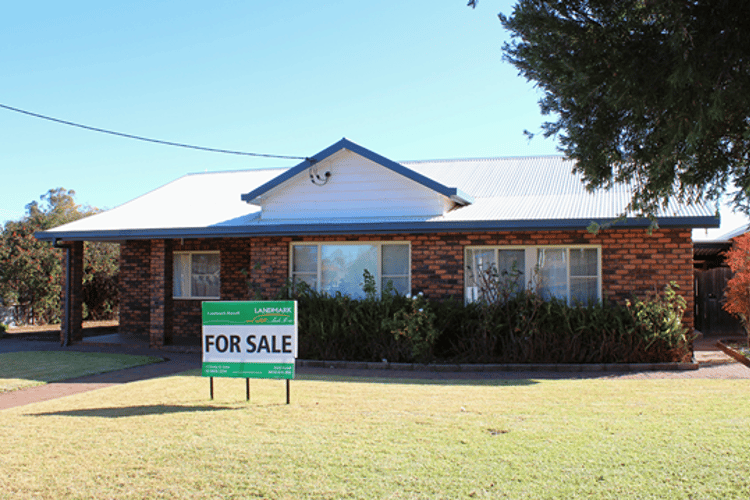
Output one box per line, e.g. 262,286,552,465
201,301,297,379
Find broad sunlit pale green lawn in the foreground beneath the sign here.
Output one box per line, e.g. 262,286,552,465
0,372,750,499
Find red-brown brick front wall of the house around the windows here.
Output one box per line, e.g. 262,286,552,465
114,229,693,339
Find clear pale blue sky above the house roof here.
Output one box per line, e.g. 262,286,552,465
0,0,557,222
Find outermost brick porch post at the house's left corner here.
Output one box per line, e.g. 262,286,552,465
55,241,83,346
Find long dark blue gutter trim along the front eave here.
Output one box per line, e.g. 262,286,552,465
35,216,719,241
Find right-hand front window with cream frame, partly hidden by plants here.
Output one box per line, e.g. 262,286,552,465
466,247,601,304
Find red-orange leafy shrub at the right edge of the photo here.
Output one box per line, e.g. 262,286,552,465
724,233,750,344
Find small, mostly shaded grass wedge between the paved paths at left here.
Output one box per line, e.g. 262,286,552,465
0,351,162,393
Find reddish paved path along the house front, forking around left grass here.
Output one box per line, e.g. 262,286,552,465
0,337,750,411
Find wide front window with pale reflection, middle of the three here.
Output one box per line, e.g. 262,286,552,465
291,242,411,298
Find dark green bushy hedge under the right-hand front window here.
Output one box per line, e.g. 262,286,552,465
448,283,692,363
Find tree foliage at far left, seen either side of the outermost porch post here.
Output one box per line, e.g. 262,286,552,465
0,188,119,323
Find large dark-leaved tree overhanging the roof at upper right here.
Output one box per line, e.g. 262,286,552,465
488,0,750,213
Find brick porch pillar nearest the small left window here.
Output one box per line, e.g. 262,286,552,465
149,240,174,347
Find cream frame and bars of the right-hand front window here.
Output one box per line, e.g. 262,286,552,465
464,245,602,305
